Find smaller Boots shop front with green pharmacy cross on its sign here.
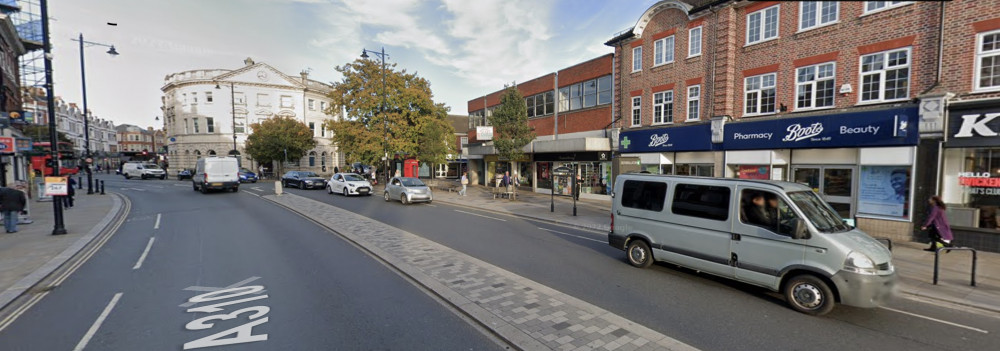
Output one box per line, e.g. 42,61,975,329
618,123,720,177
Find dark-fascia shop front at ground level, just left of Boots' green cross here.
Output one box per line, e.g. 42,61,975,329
534,151,611,200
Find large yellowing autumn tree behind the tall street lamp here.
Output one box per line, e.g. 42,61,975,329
325,59,454,177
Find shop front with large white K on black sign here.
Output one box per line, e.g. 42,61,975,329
940,104,1000,251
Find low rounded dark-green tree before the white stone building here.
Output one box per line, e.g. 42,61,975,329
246,116,316,173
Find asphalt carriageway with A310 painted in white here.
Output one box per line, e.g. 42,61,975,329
0,176,503,350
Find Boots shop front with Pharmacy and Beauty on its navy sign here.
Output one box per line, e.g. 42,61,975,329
723,107,919,228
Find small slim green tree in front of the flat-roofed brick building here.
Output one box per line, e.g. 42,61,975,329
489,86,535,161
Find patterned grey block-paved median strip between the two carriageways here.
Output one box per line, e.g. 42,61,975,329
264,194,694,351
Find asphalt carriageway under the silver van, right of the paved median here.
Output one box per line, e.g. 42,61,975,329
274,183,1000,351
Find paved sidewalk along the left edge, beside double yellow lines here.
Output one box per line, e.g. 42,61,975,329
0,190,123,309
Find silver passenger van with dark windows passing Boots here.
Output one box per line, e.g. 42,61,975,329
608,174,896,315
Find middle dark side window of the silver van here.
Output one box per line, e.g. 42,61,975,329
671,184,730,221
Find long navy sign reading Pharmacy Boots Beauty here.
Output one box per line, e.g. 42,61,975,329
723,107,920,150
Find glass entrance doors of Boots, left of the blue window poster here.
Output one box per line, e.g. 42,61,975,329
792,166,855,218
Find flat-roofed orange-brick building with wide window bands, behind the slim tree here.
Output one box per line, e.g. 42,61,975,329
467,54,614,198
